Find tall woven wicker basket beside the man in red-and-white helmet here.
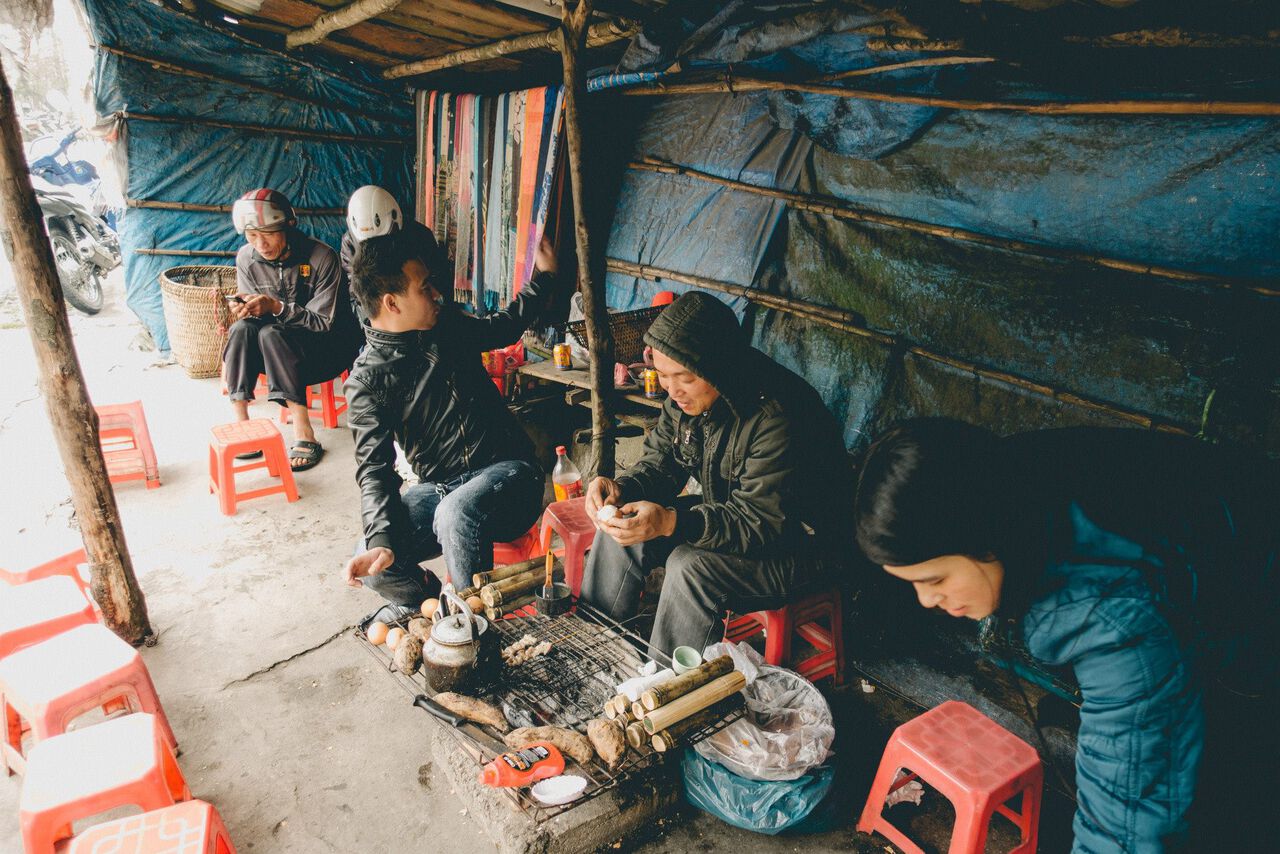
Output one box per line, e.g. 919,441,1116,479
160,265,236,379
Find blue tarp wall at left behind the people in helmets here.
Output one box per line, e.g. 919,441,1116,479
83,0,413,351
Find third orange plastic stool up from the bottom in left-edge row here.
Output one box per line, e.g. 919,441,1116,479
0,624,178,775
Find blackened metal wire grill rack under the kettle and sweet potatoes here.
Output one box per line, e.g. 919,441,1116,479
355,602,744,825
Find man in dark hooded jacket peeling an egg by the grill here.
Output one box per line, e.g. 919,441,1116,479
582,291,851,654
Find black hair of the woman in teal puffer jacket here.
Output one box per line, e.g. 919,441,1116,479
854,419,1004,566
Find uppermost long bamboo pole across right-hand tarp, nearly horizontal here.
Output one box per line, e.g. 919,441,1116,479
622,74,1280,115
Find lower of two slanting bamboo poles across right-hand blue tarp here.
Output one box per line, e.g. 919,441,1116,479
608,259,1196,435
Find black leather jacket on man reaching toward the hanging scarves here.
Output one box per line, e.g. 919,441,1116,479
346,273,556,552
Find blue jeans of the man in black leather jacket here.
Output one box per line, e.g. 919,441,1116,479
357,460,545,608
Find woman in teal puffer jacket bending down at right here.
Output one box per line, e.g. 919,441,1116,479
855,419,1280,853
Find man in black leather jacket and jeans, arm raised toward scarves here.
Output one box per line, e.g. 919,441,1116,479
346,233,557,608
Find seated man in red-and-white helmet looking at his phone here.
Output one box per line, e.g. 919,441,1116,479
223,187,360,471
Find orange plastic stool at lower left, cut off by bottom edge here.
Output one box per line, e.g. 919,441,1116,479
67,800,236,854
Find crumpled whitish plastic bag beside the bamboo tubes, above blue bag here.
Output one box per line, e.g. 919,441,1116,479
694,643,836,780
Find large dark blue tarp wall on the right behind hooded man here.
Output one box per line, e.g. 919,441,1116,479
593,3,1280,453
